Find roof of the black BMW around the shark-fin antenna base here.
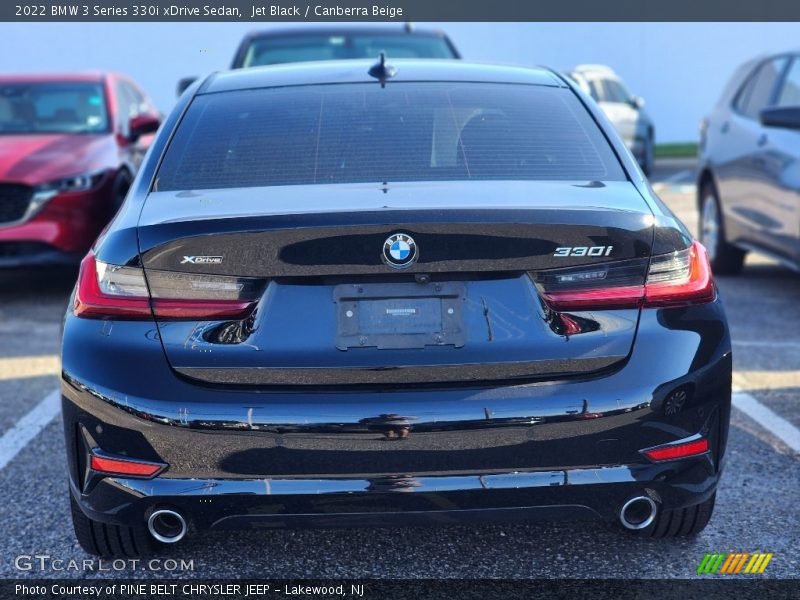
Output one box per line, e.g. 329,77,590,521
197,57,566,94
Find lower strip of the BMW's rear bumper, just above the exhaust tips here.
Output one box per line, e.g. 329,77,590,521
72,456,719,529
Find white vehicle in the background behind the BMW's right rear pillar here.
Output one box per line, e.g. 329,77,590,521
569,65,656,175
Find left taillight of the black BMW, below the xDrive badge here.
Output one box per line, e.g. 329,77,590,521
73,252,264,320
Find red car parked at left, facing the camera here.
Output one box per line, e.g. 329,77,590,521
0,73,160,267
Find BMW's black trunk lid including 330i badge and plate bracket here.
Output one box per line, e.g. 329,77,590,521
139,181,652,386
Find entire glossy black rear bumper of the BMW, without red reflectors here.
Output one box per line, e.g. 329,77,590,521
62,301,731,529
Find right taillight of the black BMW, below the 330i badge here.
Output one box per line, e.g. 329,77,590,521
535,242,715,311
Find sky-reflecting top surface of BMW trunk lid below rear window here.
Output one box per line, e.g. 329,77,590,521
138,180,654,227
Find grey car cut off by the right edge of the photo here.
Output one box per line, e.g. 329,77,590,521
697,53,800,274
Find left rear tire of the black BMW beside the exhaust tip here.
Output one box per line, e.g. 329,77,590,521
69,493,157,558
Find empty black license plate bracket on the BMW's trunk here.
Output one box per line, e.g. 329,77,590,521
333,281,467,350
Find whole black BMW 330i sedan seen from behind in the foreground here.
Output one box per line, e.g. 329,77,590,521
62,60,731,555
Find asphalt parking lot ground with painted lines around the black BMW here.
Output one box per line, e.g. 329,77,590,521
0,161,800,578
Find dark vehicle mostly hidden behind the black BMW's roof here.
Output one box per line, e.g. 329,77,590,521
177,25,461,96
